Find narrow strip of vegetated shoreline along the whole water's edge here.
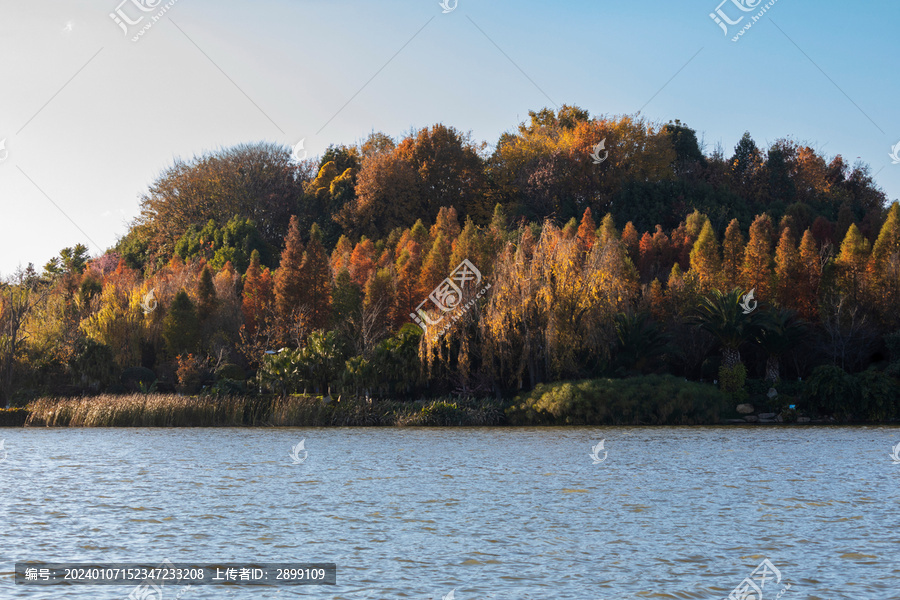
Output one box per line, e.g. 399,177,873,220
0,394,900,429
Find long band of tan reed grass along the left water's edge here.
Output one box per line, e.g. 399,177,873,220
25,394,505,427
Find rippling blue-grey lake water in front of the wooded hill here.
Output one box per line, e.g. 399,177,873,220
0,427,900,600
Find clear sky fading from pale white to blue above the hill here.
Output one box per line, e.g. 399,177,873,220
0,0,900,276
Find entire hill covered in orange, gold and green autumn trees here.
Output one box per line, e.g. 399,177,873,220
0,107,900,412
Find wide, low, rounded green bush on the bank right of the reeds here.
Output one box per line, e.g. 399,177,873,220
507,375,728,425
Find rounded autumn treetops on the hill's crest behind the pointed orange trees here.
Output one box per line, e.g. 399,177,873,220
117,106,887,270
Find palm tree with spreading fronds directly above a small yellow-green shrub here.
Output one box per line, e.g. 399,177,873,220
693,289,761,369
